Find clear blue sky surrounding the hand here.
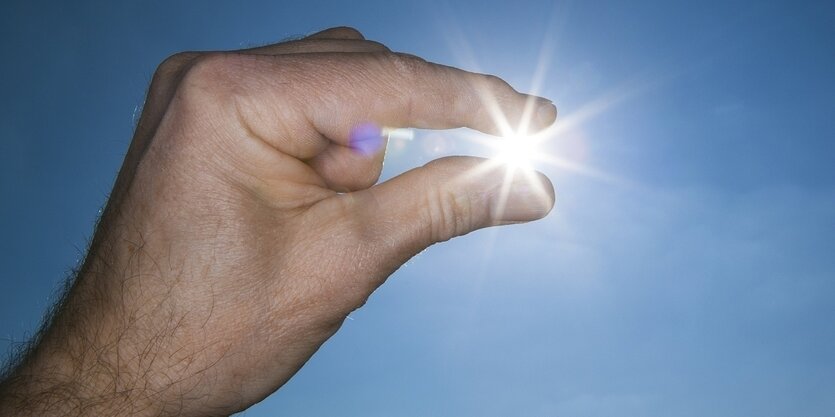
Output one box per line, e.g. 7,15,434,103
0,1,835,417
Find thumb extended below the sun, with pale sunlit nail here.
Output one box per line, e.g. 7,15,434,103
353,156,554,266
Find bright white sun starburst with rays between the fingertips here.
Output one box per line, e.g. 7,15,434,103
428,0,665,250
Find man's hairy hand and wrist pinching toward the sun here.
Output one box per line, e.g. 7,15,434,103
0,28,556,416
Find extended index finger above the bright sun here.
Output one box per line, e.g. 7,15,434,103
208,52,557,158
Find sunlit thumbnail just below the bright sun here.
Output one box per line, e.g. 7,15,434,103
490,172,554,222
